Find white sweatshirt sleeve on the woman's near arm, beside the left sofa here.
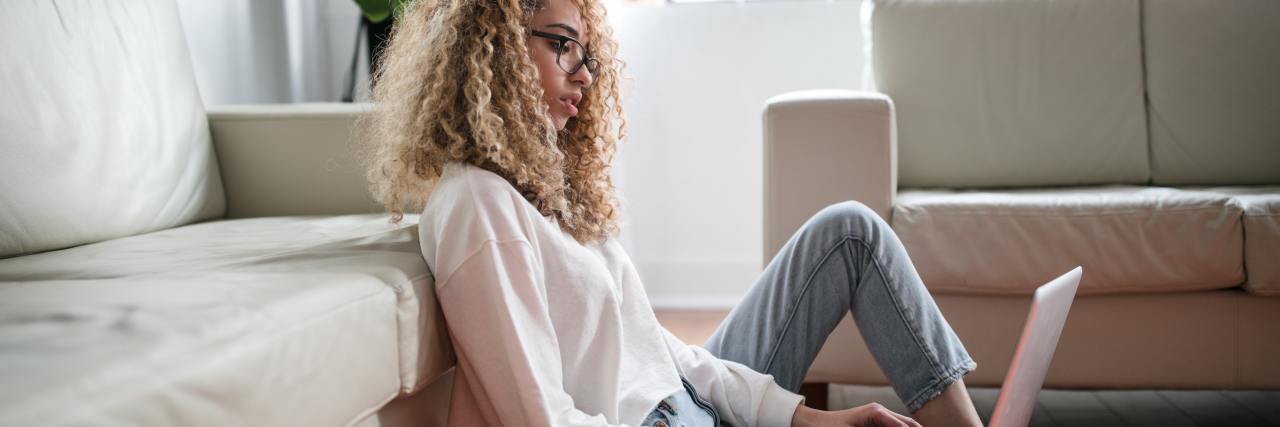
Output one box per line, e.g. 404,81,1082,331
436,240,629,426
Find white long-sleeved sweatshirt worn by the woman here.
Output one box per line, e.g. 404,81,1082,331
419,164,803,426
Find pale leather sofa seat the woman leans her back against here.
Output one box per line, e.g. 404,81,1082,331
0,215,453,426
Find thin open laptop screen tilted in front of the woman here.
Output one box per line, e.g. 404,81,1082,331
988,267,1084,427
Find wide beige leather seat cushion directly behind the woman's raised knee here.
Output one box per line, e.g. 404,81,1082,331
892,187,1244,294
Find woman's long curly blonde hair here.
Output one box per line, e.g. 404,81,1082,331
357,0,626,243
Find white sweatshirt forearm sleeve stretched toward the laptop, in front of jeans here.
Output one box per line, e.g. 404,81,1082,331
662,329,804,427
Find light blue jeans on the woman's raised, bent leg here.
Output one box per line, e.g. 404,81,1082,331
645,202,977,426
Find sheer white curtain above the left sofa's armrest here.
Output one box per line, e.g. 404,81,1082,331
178,0,369,105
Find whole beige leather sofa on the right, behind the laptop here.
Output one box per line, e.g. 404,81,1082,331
763,0,1280,396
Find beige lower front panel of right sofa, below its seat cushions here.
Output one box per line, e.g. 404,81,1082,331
808,291,1280,388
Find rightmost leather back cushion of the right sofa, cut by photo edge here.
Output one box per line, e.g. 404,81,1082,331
1142,0,1280,185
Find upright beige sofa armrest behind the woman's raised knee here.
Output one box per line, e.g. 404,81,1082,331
764,91,897,265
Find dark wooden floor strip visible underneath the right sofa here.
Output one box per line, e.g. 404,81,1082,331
828,385,1280,427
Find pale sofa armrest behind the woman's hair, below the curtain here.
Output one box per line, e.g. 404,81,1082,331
209,104,381,219
